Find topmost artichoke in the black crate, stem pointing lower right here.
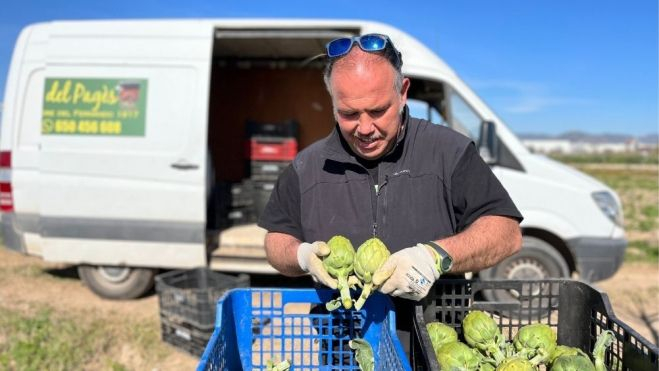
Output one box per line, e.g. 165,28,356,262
462,310,506,365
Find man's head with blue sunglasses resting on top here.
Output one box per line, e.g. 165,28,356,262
324,34,410,160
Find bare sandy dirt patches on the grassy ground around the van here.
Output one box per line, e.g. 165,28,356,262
0,248,659,370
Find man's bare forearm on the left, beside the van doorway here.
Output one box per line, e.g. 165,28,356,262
265,232,305,277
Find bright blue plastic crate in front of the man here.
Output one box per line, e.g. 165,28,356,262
197,288,412,371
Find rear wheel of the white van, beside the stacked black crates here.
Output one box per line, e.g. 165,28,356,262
78,265,156,299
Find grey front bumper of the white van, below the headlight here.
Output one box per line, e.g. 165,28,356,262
566,237,627,282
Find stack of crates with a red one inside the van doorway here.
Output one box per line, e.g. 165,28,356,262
246,120,298,217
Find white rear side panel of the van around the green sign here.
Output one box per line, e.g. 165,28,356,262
2,21,213,266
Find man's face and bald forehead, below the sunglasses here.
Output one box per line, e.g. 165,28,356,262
330,48,409,160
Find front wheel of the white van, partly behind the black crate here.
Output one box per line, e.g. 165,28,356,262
479,236,570,307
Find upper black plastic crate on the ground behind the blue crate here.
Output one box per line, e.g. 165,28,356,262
156,268,249,329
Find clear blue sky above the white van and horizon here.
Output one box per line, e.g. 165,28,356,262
0,0,659,135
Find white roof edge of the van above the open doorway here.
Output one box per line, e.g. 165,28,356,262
26,18,455,80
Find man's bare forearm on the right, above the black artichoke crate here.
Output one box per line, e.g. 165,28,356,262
435,215,522,272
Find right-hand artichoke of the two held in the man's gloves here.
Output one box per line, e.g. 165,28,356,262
354,237,393,310
